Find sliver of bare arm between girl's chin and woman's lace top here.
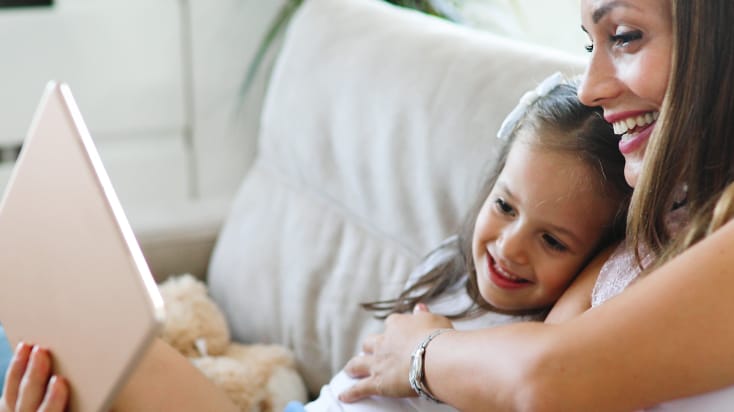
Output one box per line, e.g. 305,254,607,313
545,243,618,323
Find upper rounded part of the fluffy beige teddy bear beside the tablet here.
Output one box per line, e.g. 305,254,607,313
158,274,230,357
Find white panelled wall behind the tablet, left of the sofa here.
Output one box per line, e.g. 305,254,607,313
0,0,288,271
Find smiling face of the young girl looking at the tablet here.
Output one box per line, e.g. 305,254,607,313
472,137,616,311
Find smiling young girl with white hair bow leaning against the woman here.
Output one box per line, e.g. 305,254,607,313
287,73,630,412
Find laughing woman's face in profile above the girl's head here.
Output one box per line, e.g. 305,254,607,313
579,0,673,187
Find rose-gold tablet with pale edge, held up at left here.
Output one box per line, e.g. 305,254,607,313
0,83,163,412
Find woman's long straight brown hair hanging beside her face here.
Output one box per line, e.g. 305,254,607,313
627,0,734,265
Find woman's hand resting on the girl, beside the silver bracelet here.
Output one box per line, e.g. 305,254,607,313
339,304,452,402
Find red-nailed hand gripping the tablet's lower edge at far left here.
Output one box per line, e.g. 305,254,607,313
0,342,69,412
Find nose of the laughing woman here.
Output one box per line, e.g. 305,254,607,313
578,51,621,106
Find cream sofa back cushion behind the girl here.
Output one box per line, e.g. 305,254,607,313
200,0,582,392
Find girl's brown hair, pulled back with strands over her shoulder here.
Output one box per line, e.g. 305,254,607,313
363,81,631,318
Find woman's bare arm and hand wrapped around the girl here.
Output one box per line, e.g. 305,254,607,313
344,222,734,411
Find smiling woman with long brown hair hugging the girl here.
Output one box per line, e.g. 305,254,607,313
343,0,734,411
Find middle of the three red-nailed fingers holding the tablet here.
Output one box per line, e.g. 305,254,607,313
16,346,51,412
